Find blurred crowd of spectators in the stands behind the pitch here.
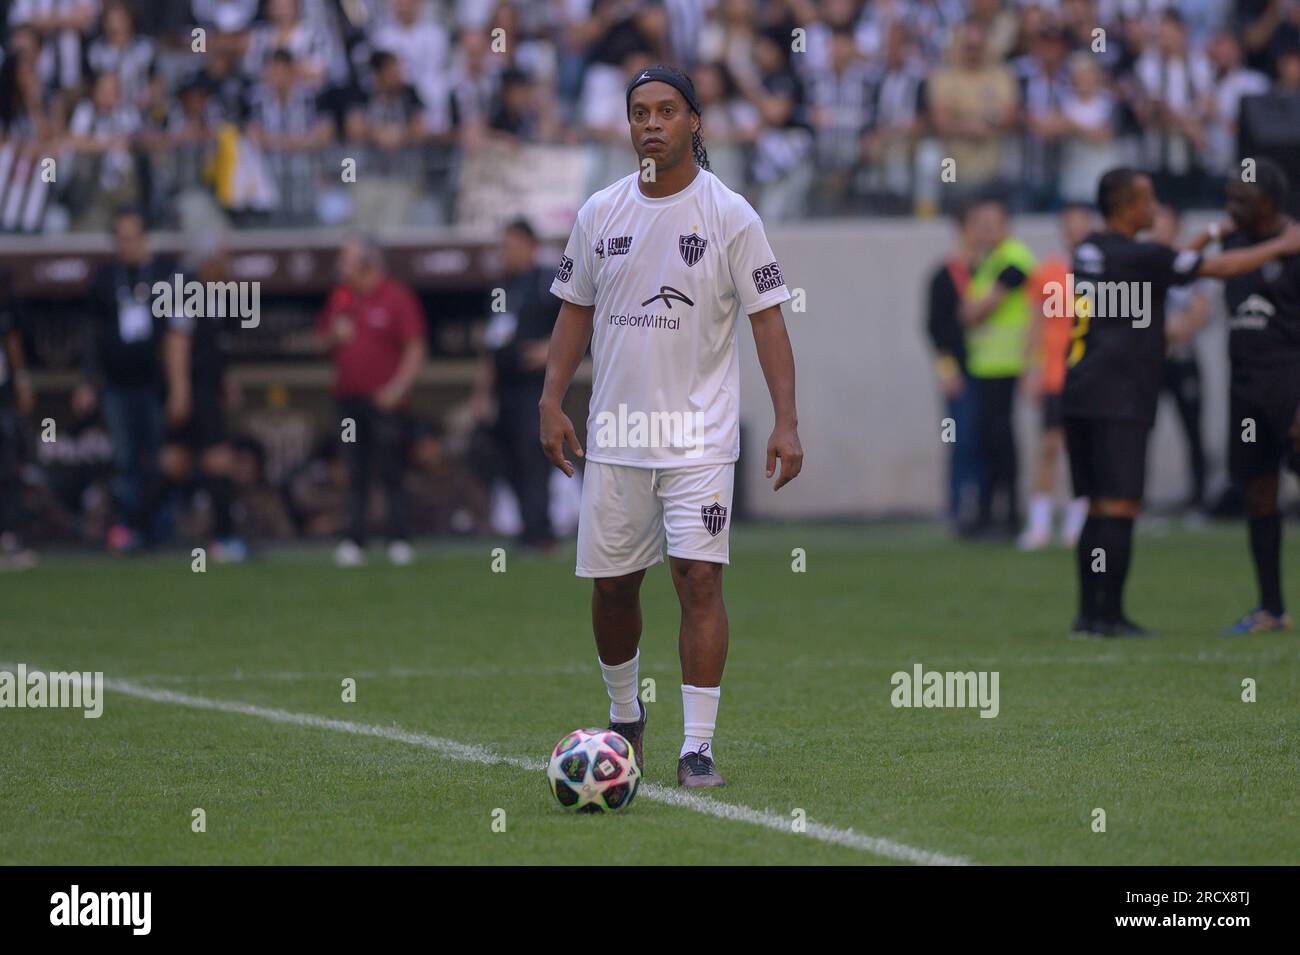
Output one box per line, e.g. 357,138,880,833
0,0,1300,231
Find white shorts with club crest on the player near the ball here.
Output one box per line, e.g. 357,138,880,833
576,461,736,577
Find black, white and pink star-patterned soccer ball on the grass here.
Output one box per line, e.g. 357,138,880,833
546,729,641,812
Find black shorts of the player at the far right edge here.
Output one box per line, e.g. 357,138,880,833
1227,368,1300,482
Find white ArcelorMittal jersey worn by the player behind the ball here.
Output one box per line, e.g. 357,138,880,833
551,169,790,468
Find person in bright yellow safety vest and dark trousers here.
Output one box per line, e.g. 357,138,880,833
958,199,1035,538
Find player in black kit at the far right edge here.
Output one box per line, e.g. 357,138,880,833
1223,159,1300,635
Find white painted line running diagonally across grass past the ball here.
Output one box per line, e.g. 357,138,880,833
0,664,972,865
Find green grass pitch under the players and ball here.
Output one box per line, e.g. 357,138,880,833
0,525,1300,864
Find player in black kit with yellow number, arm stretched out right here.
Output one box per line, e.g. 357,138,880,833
1063,168,1300,637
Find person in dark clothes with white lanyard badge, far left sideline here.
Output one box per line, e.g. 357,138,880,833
73,208,189,552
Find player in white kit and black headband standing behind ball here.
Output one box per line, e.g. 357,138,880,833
538,66,803,789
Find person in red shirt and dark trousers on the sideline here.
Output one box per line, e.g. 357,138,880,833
316,235,426,567
